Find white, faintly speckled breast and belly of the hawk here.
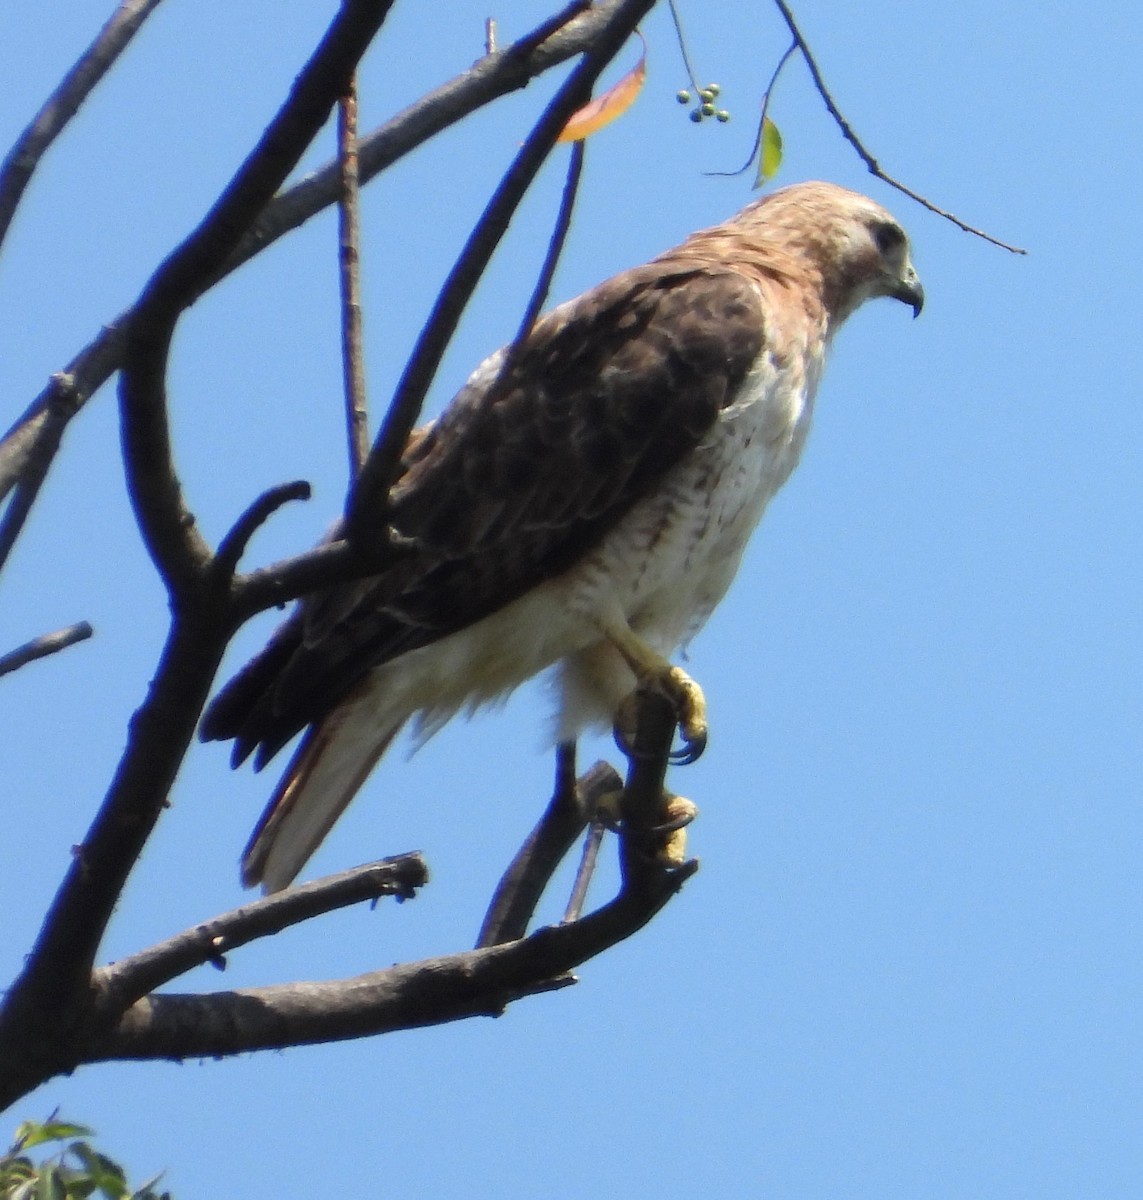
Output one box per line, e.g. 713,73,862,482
354,354,819,739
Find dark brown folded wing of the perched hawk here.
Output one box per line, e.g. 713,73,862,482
202,259,765,767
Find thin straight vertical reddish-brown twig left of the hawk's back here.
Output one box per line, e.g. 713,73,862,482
337,76,369,479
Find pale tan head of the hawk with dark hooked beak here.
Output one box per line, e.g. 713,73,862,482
731,182,924,329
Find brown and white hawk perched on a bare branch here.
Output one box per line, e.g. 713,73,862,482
202,182,924,892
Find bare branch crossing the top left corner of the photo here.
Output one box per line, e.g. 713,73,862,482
0,0,160,253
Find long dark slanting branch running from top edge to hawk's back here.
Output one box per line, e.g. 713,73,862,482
346,0,654,541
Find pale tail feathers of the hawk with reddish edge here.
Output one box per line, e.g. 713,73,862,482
243,706,405,893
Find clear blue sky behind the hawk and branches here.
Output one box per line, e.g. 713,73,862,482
0,0,1143,1200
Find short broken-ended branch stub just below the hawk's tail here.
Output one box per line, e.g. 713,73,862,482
92,853,429,1018
